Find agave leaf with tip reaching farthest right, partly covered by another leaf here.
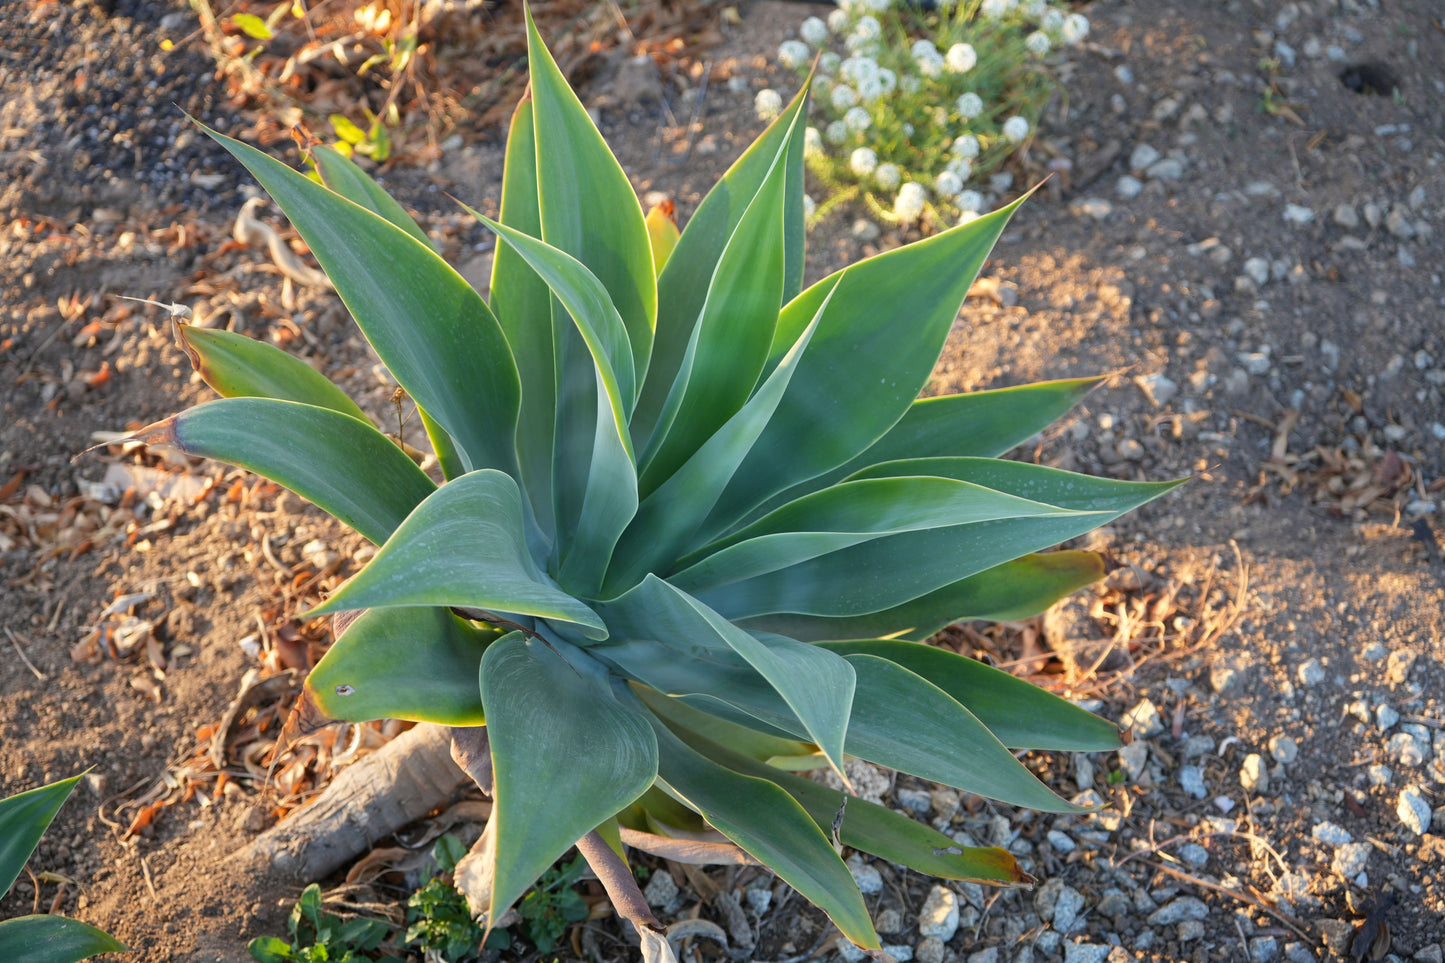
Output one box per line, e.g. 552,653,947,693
695,458,1179,619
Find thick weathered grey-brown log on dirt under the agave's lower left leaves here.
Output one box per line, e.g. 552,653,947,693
236,723,471,883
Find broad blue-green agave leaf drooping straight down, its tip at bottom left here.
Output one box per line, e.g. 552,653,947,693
481,632,657,920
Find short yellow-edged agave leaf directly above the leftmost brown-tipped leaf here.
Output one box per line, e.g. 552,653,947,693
176,324,368,422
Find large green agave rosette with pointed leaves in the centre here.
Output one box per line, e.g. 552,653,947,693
137,9,1172,947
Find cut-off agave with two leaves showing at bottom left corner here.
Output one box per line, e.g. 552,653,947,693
0,776,126,963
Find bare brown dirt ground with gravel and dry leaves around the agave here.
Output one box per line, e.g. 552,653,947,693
0,0,1445,963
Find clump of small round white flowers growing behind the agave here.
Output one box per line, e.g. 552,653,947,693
757,0,1090,230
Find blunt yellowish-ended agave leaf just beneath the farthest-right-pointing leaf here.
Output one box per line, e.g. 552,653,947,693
741,551,1104,642
